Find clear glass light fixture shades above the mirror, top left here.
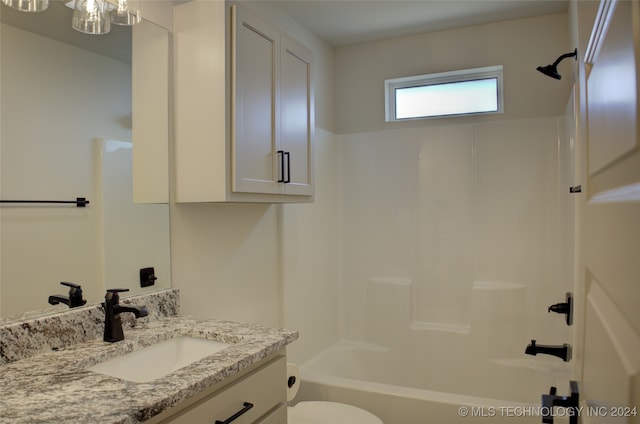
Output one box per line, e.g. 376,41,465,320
2,0,142,35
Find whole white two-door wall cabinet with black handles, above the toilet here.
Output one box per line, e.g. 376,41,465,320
174,0,314,203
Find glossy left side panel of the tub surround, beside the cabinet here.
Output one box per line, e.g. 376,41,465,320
280,129,342,362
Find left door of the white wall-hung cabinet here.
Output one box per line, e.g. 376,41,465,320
231,6,280,193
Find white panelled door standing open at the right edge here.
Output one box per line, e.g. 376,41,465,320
576,1,640,423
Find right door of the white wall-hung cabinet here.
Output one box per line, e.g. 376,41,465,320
280,34,314,195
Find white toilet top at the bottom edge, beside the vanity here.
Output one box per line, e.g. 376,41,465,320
287,401,384,424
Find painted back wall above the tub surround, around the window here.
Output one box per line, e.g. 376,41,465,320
336,14,573,134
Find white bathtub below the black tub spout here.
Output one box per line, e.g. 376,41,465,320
296,340,569,424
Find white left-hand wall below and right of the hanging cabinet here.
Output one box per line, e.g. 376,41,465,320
171,2,339,348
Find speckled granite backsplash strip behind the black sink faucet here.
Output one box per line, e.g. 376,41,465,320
0,289,180,365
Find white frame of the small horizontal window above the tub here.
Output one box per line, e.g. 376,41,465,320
384,65,504,122
